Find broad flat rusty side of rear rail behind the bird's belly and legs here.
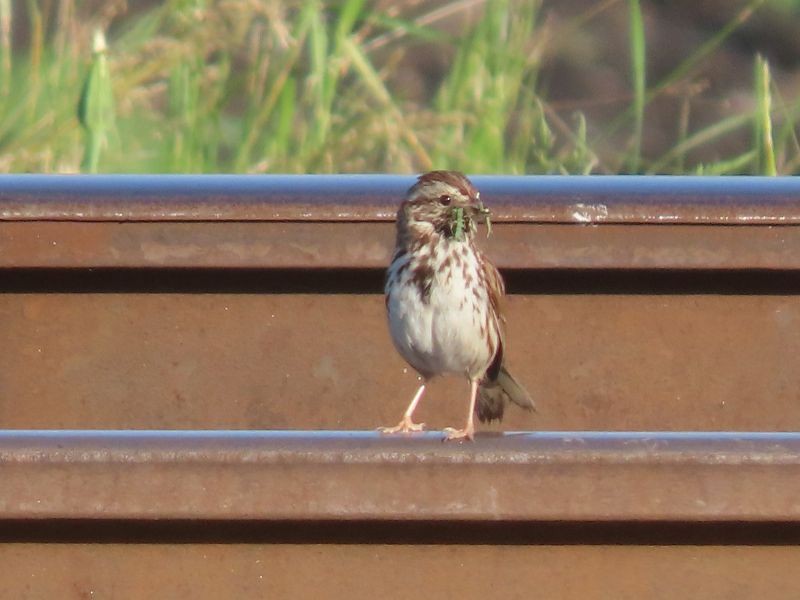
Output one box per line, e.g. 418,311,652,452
0,288,800,431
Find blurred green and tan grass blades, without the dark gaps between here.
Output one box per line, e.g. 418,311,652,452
0,0,800,175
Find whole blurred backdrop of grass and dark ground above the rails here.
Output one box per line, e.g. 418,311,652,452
0,0,800,174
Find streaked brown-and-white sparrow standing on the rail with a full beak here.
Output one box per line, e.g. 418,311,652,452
381,171,534,440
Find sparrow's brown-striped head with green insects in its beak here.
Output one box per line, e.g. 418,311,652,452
397,171,490,240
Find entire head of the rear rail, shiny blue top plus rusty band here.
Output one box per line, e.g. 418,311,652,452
0,175,800,269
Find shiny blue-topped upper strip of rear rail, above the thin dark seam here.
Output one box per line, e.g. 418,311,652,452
0,175,800,225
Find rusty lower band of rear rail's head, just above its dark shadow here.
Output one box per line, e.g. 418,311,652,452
0,222,800,269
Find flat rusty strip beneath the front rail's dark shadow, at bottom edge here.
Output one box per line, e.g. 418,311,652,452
0,540,800,600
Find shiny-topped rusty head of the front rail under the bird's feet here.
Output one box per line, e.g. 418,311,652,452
0,430,800,521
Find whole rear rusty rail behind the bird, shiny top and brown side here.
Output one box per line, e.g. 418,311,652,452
0,175,800,431
